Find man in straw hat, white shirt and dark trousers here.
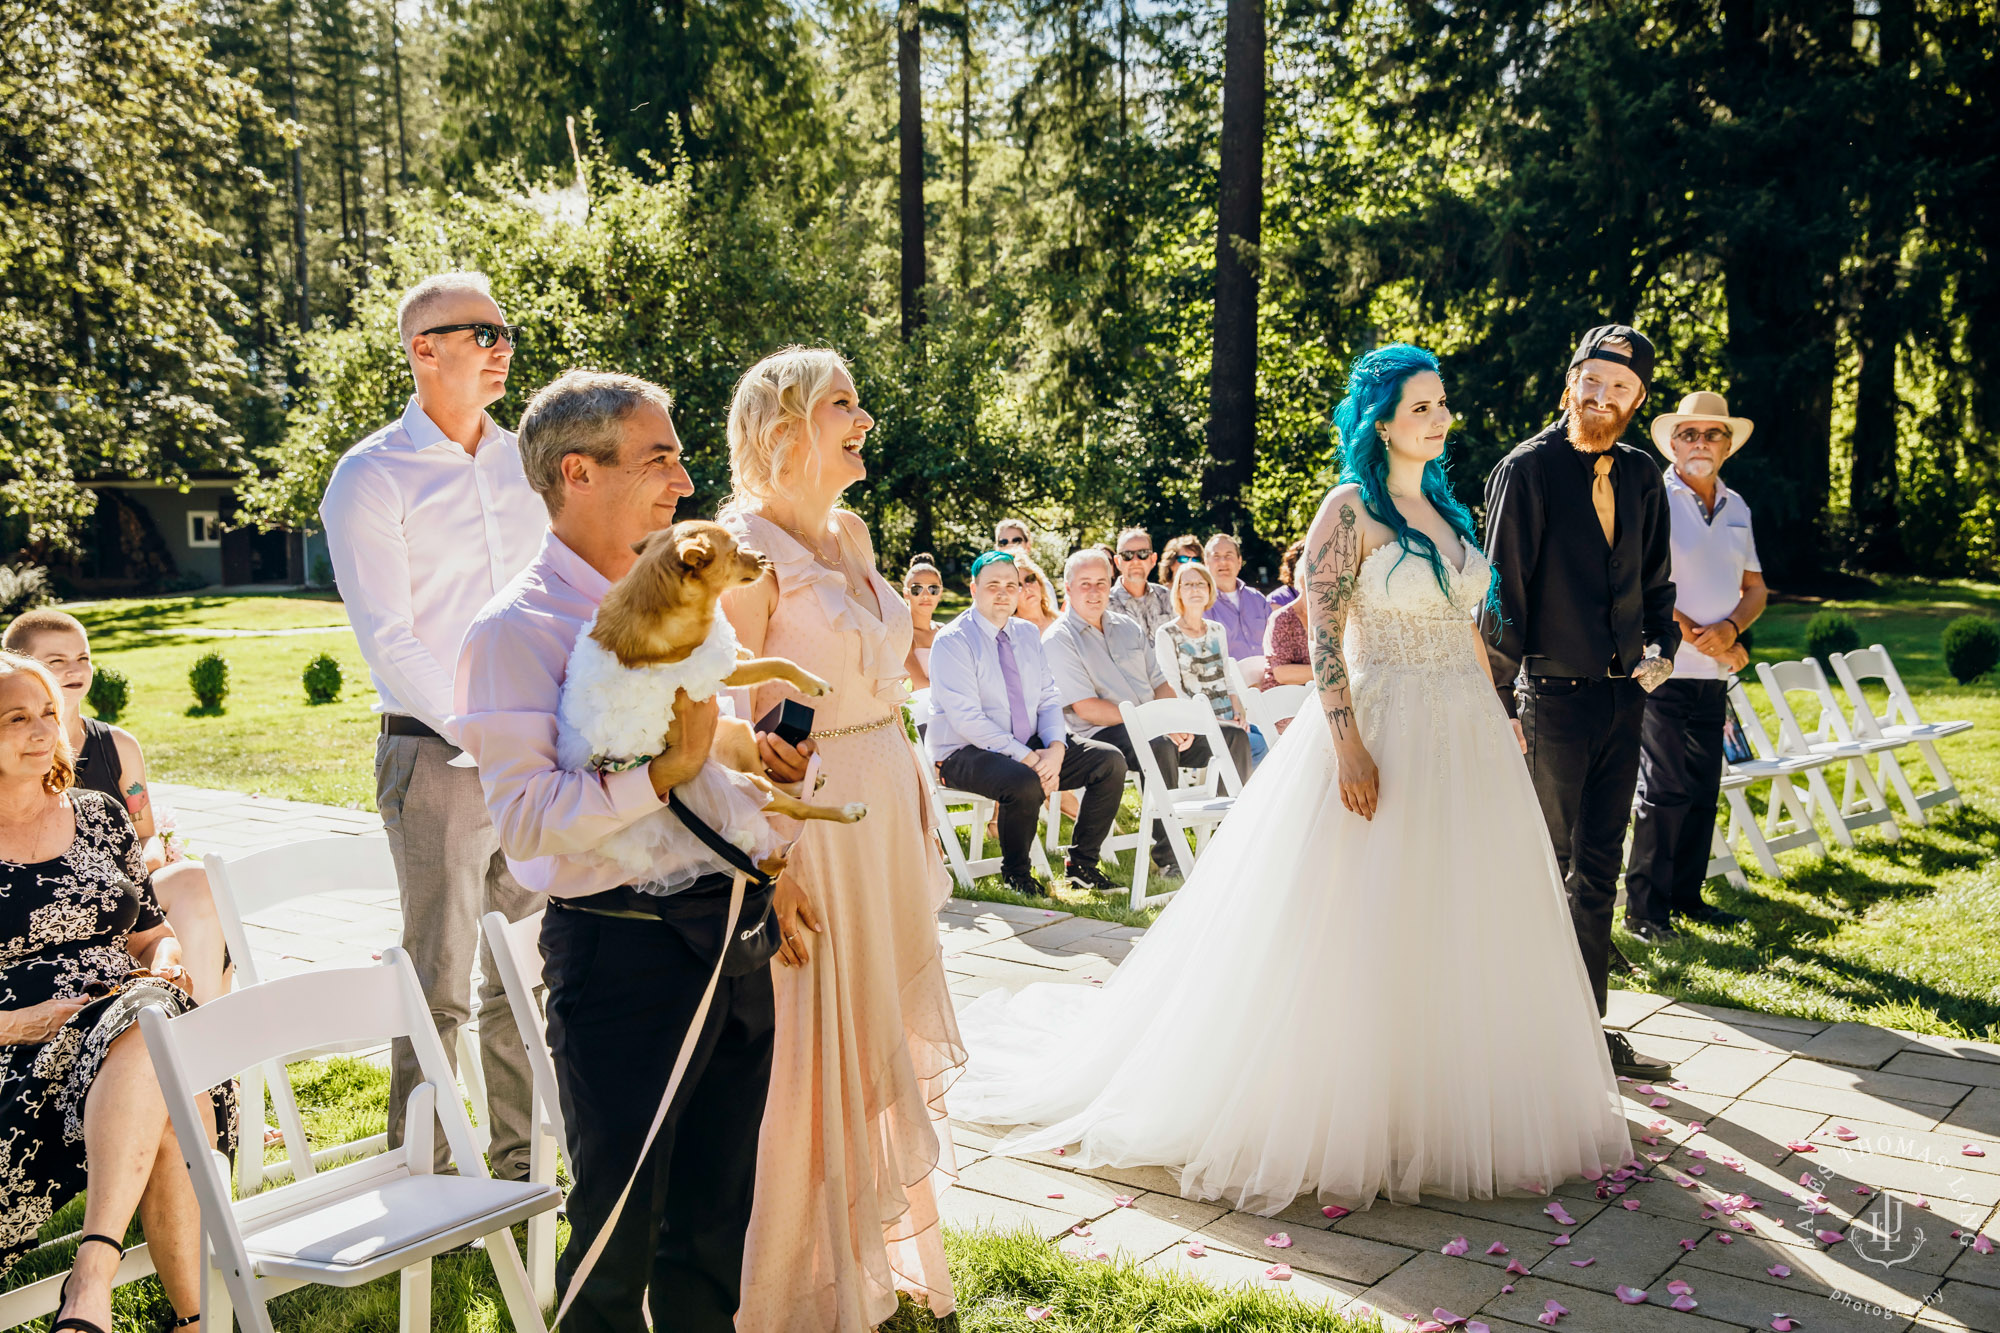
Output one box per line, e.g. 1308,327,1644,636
1626,392,1766,943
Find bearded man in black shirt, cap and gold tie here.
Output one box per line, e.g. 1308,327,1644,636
1480,324,1680,1083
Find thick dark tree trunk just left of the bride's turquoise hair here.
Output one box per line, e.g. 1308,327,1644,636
1202,0,1264,538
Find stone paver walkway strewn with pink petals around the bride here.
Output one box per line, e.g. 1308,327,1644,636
156,785,2000,1333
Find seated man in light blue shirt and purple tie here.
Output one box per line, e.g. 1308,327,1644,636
924,550,1126,897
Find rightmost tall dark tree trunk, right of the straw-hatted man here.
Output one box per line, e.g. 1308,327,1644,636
1848,0,1914,570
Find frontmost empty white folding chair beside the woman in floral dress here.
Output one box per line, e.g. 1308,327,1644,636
138,949,562,1333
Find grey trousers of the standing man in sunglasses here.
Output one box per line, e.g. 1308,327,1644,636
376,735,548,1179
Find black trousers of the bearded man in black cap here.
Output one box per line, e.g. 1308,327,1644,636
1518,677,1646,1015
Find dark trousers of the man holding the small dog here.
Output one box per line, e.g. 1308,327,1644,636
542,881,776,1333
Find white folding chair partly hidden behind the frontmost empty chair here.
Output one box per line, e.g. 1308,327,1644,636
202,833,492,1197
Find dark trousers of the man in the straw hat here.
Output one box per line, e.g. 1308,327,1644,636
1626,681,1730,925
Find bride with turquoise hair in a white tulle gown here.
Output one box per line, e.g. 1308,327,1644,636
952,344,1632,1215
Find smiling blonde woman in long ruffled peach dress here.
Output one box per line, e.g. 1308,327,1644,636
724,348,964,1333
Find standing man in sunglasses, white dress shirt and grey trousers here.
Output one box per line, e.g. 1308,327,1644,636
320,272,548,1179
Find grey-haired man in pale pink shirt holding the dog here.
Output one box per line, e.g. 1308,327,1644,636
454,370,804,1333
